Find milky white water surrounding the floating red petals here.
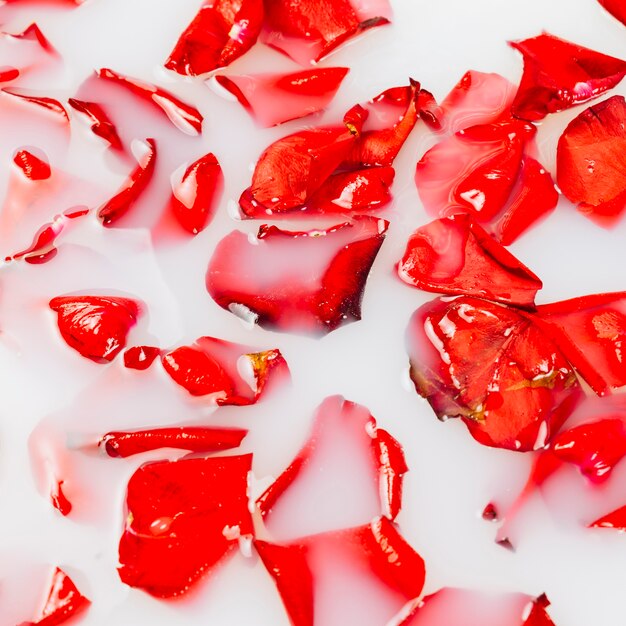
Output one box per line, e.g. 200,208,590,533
0,0,626,626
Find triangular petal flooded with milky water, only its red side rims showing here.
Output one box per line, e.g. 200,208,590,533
257,396,408,538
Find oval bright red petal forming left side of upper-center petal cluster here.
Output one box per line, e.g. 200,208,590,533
239,126,356,219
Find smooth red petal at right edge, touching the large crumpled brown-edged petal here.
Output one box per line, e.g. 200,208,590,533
537,291,626,395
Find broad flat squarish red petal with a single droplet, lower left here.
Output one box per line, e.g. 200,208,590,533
119,455,253,598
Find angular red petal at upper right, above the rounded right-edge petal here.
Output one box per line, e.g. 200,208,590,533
510,33,626,121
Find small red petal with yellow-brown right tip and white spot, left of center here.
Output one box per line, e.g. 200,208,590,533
162,337,289,405
